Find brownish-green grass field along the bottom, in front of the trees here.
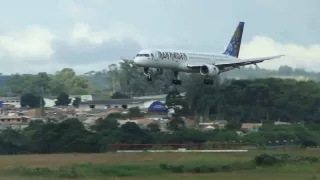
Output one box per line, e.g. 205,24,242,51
0,150,320,180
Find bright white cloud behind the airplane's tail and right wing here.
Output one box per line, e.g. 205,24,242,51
240,36,320,71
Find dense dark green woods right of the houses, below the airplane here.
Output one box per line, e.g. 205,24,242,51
167,75,320,124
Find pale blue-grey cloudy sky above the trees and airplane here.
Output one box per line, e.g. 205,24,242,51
0,0,320,74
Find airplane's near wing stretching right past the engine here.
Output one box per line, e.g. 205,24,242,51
187,55,284,71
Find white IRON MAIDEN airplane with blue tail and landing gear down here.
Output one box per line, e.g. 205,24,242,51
121,22,283,85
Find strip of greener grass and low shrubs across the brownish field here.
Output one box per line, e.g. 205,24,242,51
7,154,320,178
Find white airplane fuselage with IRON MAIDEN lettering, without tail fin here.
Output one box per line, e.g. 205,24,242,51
134,49,240,73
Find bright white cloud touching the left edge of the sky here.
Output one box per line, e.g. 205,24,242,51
0,26,55,60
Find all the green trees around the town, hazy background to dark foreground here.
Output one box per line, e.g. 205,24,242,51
0,62,320,154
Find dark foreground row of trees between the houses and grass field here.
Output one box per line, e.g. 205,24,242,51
0,114,320,154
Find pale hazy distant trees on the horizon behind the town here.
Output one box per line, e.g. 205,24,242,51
0,61,320,98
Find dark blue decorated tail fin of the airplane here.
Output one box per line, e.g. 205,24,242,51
223,22,244,57
